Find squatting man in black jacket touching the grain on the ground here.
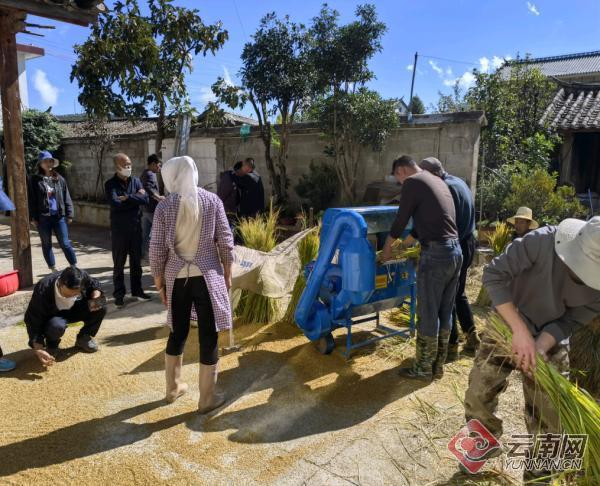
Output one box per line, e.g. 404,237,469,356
25,267,106,366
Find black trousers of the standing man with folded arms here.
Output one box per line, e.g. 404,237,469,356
111,228,142,299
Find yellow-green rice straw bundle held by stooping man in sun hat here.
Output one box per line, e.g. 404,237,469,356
487,315,600,485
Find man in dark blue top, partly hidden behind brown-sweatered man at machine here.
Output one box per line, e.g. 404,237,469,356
419,157,479,356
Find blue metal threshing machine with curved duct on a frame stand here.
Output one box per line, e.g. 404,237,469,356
295,206,416,357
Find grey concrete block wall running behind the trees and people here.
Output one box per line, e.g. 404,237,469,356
63,112,485,205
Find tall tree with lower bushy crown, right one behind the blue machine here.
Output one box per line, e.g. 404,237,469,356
310,4,398,202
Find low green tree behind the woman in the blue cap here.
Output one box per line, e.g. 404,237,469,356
22,110,63,173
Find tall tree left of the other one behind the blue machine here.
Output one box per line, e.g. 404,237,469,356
213,13,315,204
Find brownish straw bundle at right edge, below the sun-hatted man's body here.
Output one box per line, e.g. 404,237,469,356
569,317,600,399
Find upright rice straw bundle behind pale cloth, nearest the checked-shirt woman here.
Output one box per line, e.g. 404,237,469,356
236,202,279,324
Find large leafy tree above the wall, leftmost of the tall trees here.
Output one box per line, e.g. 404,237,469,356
71,0,228,153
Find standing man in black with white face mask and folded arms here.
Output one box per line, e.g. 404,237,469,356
104,154,150,307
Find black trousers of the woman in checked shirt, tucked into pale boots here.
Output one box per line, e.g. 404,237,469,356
167,277,219,365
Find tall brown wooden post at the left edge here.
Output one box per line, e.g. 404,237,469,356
0,9,33,288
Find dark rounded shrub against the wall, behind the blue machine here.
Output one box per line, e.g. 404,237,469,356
295,162,338,213
